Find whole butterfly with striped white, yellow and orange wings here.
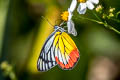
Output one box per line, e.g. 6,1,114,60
37,26,80,72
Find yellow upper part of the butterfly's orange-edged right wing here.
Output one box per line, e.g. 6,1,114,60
53,32,77,55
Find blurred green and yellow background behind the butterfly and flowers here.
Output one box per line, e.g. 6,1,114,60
0,0,120,80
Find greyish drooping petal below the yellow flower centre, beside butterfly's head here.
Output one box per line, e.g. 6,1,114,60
67,20,77,36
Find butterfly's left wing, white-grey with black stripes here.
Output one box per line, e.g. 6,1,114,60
37,32,57,71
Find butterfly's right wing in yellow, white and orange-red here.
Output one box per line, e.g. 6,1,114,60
53,32,80,70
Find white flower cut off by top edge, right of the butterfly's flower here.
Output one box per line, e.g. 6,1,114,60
77,0,99,14
